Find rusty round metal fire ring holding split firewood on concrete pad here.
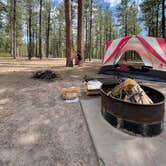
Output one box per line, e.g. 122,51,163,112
101,84,165,136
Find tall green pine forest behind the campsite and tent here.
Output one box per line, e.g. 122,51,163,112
0,0,166,66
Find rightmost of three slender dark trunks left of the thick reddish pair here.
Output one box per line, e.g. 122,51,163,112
46,4,51,58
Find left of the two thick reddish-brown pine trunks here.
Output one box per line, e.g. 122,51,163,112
64,0,73,67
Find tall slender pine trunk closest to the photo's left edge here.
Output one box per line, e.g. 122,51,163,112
13,0,17,59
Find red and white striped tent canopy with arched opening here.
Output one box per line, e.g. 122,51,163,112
103,36,166,71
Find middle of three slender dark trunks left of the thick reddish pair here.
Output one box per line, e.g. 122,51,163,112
39,0,43,59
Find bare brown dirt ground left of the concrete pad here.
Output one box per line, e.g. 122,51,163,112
0,58,101,166
